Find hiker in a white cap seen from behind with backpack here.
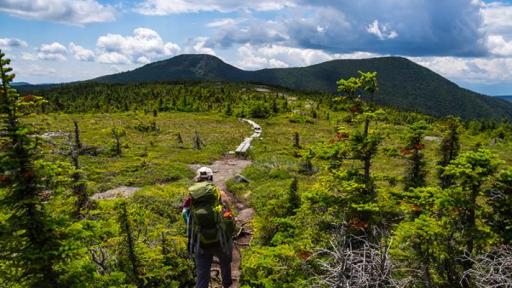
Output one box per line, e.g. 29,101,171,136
182,167,235,288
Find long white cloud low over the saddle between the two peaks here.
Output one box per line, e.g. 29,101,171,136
237,44,377,70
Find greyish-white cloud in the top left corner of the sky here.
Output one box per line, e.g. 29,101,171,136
0,0,115,25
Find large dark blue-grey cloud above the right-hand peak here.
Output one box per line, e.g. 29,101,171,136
211,0,487,57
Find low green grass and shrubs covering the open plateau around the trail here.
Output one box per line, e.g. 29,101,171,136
0,70,512,287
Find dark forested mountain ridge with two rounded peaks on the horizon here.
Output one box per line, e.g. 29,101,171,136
34,54,512,120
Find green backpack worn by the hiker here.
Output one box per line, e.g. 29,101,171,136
189,182,230,253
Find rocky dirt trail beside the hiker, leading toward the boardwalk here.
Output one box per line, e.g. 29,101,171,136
190,121,261,288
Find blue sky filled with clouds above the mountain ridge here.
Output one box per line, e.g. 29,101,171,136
0,0,512,95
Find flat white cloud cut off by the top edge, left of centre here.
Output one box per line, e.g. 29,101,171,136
135,0,293,15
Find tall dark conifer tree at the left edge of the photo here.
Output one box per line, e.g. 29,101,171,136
0,51,61,287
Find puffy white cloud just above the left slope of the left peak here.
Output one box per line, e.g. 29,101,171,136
96,28,181,64
